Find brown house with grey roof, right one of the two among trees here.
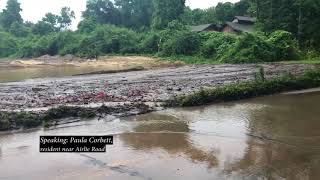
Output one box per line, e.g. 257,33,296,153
221,16,256,34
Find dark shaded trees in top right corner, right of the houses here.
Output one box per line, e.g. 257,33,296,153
257,0,320,50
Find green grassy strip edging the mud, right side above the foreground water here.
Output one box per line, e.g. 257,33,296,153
166,69,320,107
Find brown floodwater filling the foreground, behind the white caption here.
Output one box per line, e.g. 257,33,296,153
0,92,320,180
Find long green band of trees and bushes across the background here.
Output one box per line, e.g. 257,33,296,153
0,0,320,63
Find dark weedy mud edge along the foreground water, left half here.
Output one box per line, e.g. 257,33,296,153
0,103,154,131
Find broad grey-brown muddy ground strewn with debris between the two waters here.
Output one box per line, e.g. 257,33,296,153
0,64,313,131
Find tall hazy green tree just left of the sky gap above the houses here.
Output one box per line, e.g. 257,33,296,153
152,0,185,29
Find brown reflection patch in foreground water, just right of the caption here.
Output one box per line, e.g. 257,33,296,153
120,113,218,168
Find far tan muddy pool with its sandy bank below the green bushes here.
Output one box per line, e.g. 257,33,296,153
0,56,179,83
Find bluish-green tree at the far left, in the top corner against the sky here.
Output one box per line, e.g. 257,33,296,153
1,0,23,30
